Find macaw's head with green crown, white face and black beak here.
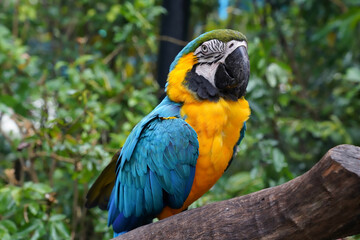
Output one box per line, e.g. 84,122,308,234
166,29,250,102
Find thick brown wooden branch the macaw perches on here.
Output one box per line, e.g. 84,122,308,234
116,145,360,240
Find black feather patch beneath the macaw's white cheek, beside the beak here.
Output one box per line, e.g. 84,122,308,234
184,65,219,102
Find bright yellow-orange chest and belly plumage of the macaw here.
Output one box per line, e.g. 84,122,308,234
181,99,250,205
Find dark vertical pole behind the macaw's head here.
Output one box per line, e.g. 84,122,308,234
157,0,190,93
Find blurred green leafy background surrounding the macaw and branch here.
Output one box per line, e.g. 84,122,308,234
0,0,360,240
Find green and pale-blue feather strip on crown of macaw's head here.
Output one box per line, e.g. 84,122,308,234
170,29,247,71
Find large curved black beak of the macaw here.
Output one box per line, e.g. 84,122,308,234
215,46,250,101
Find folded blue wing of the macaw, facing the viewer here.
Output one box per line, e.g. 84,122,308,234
108,99,199,233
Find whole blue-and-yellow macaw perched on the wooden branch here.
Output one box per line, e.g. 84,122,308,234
85,29,250,237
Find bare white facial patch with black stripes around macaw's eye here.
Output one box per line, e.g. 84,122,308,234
194,39,247,87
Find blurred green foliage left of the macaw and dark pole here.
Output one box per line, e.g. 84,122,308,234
0,1,160,239
